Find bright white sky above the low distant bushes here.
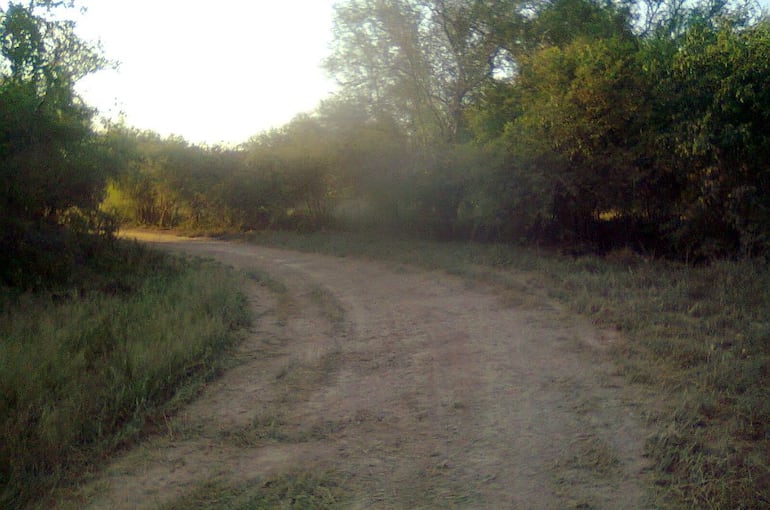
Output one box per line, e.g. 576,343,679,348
67,0,335,144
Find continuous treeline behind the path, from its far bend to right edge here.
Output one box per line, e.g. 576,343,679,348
106,0,770,260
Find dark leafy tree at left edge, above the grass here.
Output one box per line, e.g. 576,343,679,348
0,2,115,286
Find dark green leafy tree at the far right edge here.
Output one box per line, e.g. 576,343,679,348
663,17,770,256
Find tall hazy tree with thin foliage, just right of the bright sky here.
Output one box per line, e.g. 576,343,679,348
326,0,518,143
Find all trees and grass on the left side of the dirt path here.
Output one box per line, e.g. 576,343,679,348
0,4,247,508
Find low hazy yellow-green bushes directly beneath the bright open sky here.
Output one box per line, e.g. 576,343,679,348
102,116,338,230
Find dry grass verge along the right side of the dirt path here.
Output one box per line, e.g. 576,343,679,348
242,233,770,509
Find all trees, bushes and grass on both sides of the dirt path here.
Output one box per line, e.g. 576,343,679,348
0,0,770,508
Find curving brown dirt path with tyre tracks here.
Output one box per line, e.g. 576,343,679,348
67,233,652,509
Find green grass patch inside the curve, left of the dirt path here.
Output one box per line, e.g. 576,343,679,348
0,243,248,508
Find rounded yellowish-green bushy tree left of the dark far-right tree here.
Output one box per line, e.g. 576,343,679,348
496,34,648,242
